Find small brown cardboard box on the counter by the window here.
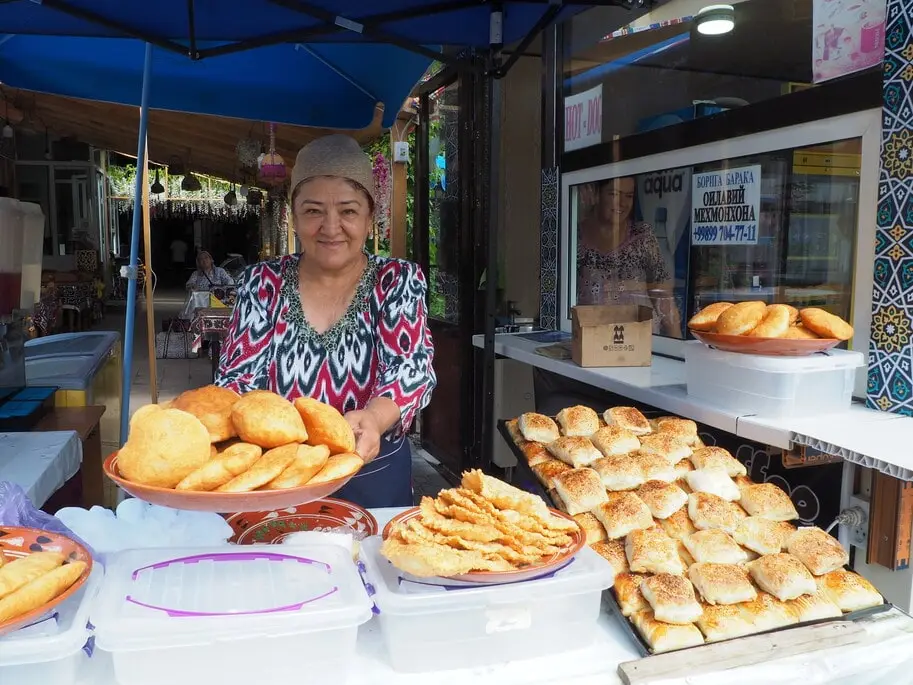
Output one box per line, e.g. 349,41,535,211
571,305,653,366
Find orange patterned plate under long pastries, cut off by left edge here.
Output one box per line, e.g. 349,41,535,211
0,526,92,635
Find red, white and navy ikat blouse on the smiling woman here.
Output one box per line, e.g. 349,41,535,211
216,255,436,434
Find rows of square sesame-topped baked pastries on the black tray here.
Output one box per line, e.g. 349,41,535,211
508,406,884,653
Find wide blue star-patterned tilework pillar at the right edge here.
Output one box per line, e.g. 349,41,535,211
866,0,913,416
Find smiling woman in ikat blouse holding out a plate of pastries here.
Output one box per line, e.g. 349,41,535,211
217,135,435,507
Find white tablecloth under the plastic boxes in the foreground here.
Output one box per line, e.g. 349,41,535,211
78,509,913,685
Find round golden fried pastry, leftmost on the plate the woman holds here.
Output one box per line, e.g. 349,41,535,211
117,409,212,488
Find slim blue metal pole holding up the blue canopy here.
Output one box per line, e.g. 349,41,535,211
120,43,152,445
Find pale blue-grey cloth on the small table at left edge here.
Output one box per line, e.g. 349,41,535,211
0,431,82,507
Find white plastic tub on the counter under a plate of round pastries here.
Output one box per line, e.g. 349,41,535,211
685,342,865,418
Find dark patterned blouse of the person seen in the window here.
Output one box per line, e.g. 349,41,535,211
577,223,670,305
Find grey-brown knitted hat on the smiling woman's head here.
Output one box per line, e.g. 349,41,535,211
289,133,374,202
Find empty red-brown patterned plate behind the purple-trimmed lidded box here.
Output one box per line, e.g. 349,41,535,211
225,497,377,545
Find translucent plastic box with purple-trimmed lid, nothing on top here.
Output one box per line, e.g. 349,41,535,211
92,544,371,685
